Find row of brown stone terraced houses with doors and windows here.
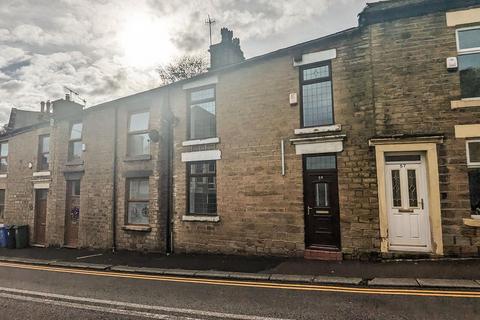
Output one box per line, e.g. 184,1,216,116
0,0,480,259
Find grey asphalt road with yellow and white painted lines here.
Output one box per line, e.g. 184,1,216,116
0,263,480,320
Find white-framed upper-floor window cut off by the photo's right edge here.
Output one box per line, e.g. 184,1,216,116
457,26,480,98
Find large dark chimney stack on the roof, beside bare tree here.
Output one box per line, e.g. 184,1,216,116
209,28,245,70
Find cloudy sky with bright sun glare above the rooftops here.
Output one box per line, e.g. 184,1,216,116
0,0,375,123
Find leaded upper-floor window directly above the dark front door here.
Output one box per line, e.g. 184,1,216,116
300,62,333,127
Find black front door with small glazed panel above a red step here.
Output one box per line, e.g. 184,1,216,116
304,156,340,250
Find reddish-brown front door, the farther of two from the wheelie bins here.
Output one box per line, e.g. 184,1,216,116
65,180,80,248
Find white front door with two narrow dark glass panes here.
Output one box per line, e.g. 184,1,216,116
385,154,431,252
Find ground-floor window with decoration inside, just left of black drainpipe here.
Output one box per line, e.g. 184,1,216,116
127,178,150,224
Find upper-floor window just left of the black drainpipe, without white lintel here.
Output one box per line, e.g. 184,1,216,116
127,111,150,156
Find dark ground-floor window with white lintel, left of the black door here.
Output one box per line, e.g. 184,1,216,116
187,161,217,215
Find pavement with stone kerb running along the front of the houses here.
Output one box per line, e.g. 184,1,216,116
0,248,480,290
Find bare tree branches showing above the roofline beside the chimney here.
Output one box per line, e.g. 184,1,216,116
157,55,208,84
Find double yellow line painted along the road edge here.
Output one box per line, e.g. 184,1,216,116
0,262,480,299
